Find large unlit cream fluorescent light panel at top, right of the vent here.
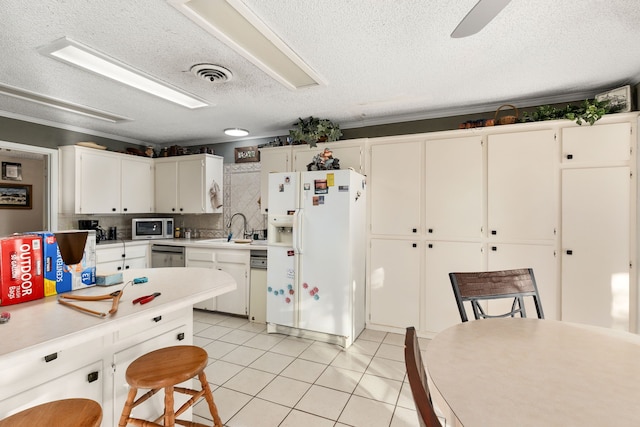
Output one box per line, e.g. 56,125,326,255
168,0,326,89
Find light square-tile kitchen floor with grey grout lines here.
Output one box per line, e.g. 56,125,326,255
193,310,428,427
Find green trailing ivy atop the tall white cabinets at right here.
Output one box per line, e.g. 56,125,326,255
521,99,611,125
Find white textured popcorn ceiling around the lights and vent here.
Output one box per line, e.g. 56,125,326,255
0,0,640,145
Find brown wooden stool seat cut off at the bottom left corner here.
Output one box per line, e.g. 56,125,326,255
0,399,102,427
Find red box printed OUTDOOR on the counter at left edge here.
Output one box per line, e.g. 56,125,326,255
0,235,44,305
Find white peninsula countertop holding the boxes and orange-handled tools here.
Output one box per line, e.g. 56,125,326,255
0,267,236,363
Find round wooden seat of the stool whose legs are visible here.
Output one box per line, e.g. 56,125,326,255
126,345,209,389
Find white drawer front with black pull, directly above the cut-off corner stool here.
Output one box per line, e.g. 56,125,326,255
0,337,104,400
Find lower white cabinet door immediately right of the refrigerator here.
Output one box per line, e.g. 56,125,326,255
369,239,422,328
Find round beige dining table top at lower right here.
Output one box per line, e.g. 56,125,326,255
424,318,640,427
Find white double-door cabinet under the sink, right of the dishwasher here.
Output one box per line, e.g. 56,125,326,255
185,247,250,316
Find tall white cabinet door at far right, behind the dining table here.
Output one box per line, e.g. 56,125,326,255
562,167,631,330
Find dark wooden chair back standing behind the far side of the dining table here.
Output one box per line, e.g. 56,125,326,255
449,268,544,322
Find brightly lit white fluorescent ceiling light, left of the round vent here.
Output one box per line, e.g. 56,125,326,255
38,37,209,109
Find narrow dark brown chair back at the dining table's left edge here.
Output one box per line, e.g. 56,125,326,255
404,326,442,427
